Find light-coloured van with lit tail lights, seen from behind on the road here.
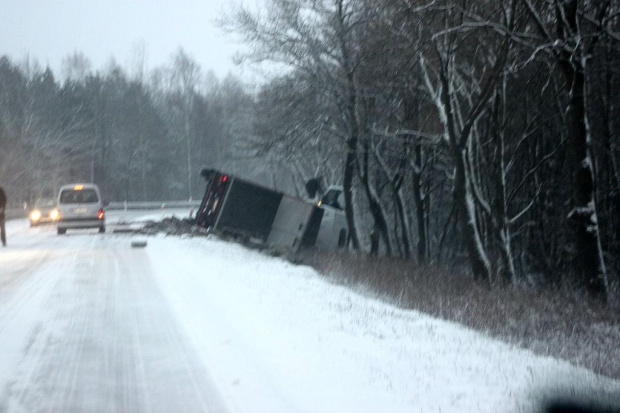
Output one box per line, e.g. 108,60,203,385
58,184,105,235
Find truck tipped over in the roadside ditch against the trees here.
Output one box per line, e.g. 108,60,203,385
196,168,348,251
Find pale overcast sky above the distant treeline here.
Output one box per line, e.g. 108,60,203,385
0,0,256,78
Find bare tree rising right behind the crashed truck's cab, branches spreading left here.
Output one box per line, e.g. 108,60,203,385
224,0,372,249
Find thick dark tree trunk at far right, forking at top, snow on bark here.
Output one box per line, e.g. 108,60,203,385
522,0,611,301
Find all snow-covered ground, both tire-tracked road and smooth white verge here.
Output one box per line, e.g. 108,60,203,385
0,213,620,412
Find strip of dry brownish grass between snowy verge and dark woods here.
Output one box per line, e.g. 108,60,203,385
301,251,620,379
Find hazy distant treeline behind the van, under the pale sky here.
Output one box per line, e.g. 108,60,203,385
0,50,253,205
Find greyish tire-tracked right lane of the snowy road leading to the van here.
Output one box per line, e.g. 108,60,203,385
0,236,225,412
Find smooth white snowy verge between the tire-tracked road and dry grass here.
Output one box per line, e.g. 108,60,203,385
147,237,620,412
